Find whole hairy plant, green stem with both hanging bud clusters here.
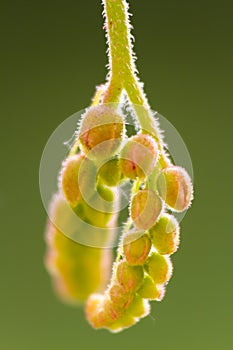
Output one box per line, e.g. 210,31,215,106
45,0,193,332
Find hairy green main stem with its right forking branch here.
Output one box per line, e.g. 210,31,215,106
103,0,169,163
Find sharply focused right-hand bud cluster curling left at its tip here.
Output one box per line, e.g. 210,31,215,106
82,103,192,332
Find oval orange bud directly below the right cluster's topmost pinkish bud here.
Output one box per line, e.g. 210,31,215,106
130,190,163,230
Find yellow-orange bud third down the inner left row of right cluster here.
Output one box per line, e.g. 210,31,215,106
123,232,151,266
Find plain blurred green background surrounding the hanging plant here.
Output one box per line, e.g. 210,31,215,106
0,0,233,350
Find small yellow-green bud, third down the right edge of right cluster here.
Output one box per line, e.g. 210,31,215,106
145,252,172,284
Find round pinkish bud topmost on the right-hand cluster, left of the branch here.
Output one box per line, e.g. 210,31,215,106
119,134,158,179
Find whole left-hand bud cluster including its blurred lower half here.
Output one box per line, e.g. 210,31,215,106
45,105,124,303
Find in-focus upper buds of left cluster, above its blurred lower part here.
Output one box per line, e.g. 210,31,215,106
59,105,124,228
